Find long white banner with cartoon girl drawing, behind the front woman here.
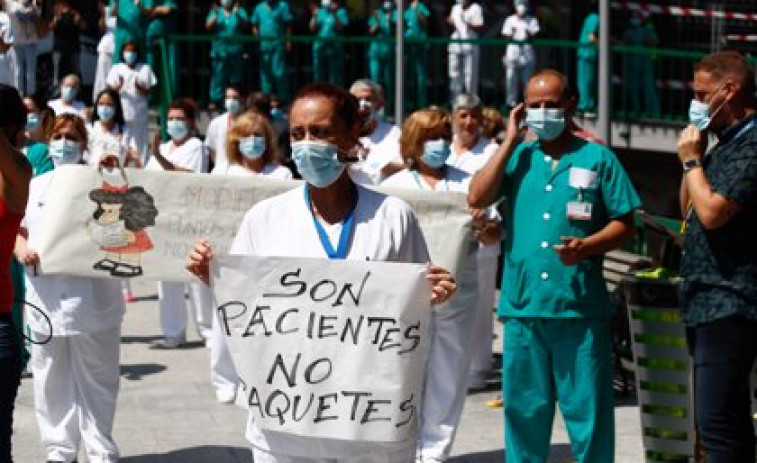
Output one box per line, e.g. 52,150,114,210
35,166,473,281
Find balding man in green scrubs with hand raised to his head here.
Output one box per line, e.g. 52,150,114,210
468,70,640,463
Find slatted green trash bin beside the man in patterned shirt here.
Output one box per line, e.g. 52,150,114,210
622,277,696,461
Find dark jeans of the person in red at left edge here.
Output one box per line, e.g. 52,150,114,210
0,314,21,463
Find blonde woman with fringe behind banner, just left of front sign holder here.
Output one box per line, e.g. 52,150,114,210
209,111,292,403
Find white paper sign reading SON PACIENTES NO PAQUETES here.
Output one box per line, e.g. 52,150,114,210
211,256,431,442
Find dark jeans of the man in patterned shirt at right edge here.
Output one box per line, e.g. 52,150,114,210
687,316,757,463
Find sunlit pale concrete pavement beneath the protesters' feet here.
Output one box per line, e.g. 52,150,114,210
13,283,644,463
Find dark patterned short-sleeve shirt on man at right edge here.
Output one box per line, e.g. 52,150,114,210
681,116,757,325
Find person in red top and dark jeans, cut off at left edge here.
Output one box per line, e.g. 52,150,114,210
0,84,32,462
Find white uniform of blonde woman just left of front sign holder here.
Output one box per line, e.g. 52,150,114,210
208,164,292,396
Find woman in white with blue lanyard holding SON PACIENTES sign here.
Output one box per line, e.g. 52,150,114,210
187,83,456,463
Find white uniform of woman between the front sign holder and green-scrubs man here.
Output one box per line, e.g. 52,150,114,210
381,166,478,461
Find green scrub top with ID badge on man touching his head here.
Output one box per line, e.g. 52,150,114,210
499,138,641,318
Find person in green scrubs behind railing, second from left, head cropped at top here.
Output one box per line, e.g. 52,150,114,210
250,0,292,100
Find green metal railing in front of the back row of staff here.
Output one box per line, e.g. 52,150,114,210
157,35,757,122
